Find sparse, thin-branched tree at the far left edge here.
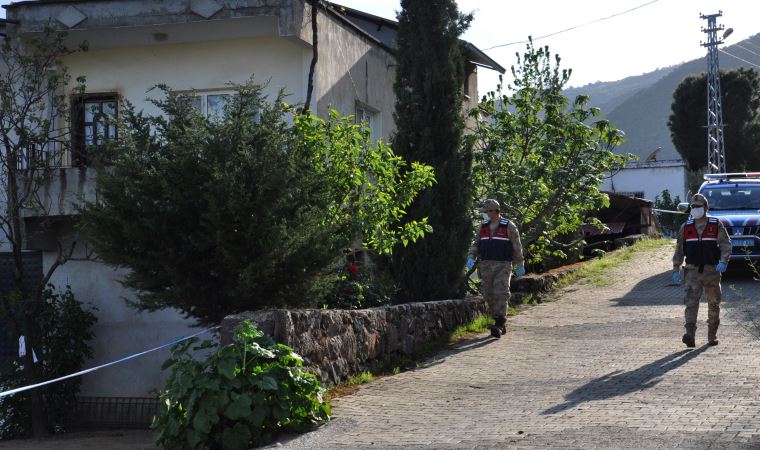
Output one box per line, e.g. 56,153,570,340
0,28,90,436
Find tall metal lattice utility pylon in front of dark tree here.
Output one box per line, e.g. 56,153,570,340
699,11,731,173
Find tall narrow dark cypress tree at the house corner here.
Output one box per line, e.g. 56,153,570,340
390,0,472,301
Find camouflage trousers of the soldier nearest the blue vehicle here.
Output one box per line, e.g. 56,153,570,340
683,265,721,338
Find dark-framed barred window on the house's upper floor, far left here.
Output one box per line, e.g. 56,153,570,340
72,94,118,166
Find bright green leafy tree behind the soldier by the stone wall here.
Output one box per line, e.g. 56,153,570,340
470,41,629,262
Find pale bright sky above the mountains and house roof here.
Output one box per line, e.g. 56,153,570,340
0,0,760,93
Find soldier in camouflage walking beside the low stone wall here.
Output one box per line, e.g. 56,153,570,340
467,199,525,339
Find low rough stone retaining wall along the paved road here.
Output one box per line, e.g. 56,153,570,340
222,297,487,384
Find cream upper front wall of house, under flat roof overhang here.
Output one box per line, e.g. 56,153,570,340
60,37,310,114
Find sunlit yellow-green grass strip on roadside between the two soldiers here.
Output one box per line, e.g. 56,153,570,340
555,239,673,288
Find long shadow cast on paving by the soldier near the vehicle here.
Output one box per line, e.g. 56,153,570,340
541,344,708,415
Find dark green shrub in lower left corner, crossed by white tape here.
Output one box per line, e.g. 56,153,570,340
0,285,97,440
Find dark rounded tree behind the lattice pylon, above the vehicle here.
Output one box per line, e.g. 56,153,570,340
668,68,760,172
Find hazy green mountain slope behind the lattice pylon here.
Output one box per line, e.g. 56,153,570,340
565,34,760,160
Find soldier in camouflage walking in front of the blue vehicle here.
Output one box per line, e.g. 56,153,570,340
673,194,731,347
